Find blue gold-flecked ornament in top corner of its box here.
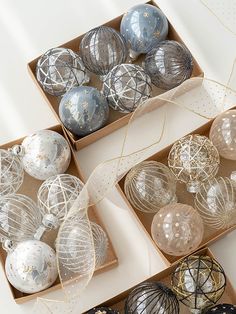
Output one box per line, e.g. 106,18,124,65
120,4,168,59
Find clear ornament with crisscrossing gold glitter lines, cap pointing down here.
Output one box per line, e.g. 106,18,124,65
168,134,220,193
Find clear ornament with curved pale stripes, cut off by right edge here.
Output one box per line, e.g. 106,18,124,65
194,177,236,229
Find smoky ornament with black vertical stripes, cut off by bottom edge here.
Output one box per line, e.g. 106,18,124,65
125,282,179,314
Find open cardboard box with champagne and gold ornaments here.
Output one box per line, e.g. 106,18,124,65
118,109,236,264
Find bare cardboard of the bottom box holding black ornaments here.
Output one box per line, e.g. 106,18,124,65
85,248,236,314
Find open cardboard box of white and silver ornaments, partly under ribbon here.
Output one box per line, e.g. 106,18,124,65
0,125,117,303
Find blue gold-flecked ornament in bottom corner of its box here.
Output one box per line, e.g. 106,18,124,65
59,86,109,137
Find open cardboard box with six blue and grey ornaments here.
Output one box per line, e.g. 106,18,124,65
28,1,203,150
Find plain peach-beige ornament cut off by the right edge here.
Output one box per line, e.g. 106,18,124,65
209,109,236,160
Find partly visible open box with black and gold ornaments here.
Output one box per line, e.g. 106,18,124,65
86,248,236,314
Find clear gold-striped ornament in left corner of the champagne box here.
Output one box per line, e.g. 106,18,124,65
124,161,177,213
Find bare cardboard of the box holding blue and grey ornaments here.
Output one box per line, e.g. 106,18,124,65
28,1,203,150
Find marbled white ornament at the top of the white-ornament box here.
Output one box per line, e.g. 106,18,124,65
21,130,71,180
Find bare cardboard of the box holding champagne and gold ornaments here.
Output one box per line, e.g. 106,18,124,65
117,115,236,264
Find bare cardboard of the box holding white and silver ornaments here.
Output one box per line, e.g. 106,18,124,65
0,125,118,303
